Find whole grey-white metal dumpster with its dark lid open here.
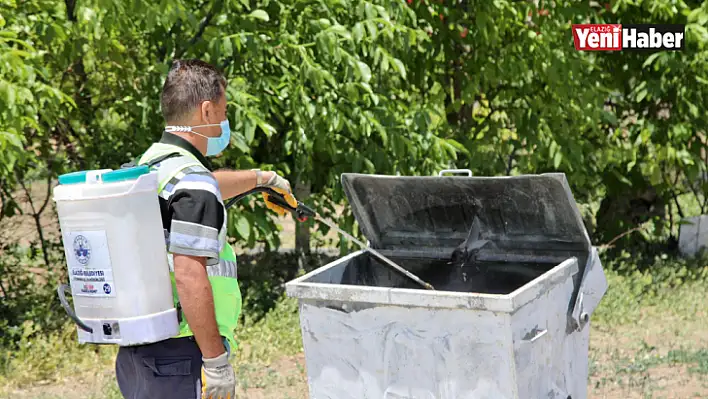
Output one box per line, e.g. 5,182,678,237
286,173,607,399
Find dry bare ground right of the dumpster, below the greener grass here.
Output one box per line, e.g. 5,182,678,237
588,300,708,399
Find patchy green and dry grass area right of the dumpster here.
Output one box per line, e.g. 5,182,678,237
589,265,708,398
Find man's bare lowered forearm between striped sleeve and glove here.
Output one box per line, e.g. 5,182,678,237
174,254,226,358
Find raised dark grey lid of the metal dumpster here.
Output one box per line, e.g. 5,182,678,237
341,173,591,260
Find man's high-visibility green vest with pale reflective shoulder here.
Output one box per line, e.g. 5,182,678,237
137,143,241,349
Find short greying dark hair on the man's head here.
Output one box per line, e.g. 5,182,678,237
160,60,226,122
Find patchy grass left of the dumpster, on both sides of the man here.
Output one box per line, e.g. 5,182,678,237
0,298,305,399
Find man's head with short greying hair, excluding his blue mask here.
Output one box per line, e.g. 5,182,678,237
161,60,226,153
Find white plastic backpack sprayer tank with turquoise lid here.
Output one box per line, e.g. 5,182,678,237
54,166,179,346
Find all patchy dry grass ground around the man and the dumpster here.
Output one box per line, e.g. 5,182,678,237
0,259,708,399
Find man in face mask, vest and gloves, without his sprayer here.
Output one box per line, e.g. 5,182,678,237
116,60,297,399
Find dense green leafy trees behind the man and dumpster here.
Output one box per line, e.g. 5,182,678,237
0,0,708,354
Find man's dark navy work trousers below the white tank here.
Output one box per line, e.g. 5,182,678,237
116,337,202,399
